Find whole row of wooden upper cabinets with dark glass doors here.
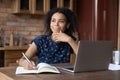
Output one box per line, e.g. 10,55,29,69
12,0,74,15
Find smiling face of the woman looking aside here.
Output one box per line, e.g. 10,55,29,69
50,12,67,33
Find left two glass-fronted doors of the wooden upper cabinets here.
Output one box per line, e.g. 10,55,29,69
12,0,47,14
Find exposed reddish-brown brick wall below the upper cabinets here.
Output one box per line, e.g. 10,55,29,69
0,0,44,44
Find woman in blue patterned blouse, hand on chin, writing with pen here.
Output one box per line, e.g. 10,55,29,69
17,8,77,69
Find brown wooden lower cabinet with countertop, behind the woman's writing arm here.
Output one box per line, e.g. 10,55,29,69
0,46,36,67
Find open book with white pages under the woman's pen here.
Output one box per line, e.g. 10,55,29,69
16,63,60,74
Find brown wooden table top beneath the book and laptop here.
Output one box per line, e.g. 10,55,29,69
0,67,120,80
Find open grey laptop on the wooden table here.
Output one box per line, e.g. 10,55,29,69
59,41,113,72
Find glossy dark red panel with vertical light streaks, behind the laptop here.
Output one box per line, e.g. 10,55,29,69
77,0,118,49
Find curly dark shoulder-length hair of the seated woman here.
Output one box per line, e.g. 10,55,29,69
45,8,77,39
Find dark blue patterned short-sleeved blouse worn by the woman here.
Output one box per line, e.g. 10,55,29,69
33,35,73,64
